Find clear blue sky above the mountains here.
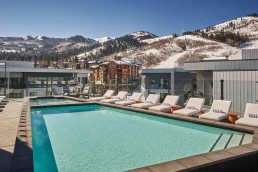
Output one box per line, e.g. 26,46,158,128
0,0,258,38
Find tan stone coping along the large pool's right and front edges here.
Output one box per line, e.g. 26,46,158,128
27,96,258,172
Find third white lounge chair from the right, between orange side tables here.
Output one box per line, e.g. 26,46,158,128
173,98,204,116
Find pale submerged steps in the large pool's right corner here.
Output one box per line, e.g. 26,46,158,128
209,133,253,152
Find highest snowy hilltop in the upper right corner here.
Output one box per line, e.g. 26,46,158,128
202,16,258,39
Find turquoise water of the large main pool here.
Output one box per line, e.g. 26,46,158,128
31,105,251,172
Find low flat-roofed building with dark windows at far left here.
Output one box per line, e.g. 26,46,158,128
0,61,91,98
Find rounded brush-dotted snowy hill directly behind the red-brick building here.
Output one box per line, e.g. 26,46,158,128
105,35,240,68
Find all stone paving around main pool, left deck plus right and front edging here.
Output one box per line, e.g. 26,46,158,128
0,97,258,172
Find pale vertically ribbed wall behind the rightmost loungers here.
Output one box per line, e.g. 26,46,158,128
213,71,258,116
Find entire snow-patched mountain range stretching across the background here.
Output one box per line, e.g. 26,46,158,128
0,16,258,68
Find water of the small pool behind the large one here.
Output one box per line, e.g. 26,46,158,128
30,98,78,106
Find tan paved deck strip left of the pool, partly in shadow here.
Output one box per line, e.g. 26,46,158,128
0,99,33,172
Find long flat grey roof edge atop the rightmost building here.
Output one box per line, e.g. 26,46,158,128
184,59,258,71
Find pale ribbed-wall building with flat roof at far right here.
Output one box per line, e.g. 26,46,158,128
184,49,258,116
